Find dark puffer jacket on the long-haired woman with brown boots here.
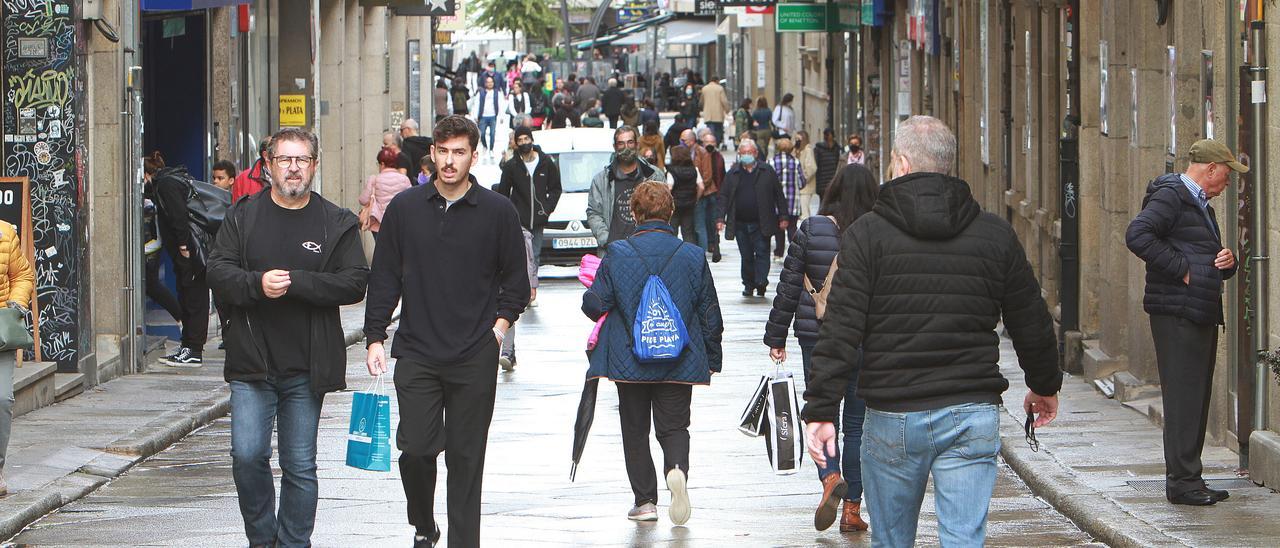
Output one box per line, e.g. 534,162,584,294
764,216,840,348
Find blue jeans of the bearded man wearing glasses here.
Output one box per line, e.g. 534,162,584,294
230,375,324,547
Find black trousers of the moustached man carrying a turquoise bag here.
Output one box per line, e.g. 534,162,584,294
396,341,498,547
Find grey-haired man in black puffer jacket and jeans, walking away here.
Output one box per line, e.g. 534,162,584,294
803,117,1062,547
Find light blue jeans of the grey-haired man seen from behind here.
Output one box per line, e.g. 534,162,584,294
863,403,1000,548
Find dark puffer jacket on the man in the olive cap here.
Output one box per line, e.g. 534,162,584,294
1125,173,1235,325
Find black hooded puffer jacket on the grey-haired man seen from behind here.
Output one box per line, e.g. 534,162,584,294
803,173,1062,423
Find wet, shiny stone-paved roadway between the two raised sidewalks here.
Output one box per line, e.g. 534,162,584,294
5,257,1091,547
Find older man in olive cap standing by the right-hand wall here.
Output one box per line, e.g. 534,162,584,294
1125,140,1249,506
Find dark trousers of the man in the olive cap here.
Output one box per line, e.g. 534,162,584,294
1151,315,1217,497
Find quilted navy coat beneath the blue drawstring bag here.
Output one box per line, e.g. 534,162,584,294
582,222,724,384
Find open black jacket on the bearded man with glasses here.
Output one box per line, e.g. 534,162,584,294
209,188,369,394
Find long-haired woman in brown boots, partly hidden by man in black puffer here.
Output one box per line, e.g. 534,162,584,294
764,164,879,533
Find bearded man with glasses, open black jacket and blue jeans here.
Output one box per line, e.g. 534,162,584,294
209,128,369,547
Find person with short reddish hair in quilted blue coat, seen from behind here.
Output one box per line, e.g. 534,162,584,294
582,182,723,525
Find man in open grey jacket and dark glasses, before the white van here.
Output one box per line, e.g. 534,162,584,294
586,125,667,250
